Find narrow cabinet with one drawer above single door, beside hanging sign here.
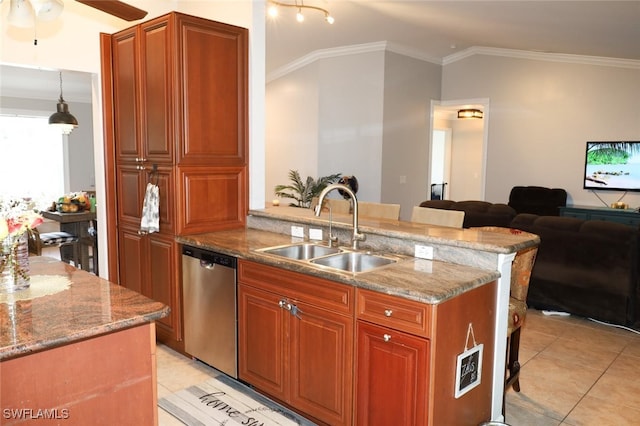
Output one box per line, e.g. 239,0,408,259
356,289,432,425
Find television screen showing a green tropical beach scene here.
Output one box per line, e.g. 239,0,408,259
584,141,640,191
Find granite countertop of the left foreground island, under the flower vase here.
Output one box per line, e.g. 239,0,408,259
0,257,169,360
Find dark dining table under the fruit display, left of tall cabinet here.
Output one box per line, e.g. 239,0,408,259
41,210,98,275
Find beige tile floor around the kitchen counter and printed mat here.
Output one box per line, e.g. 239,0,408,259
157,310,640,426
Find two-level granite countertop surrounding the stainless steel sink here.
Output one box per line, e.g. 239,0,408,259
177,207,540,304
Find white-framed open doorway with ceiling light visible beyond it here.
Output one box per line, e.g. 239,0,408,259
427,99,489,201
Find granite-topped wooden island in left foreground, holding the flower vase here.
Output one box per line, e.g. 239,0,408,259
0,257,168,425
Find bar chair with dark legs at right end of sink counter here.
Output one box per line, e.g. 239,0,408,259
473,226,538,392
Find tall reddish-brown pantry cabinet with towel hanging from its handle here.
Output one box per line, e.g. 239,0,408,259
101,12,248,351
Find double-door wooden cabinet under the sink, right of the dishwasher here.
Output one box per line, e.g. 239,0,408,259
238,261,354,425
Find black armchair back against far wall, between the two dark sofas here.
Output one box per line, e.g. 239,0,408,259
508,186,567,216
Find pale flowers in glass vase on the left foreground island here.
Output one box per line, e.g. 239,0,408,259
0,199,42,292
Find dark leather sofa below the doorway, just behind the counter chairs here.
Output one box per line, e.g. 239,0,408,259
420,200,516,228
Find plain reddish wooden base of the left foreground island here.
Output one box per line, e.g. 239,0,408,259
0,322,158,426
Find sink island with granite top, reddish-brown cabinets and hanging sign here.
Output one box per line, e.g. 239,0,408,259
177,208,539,425
